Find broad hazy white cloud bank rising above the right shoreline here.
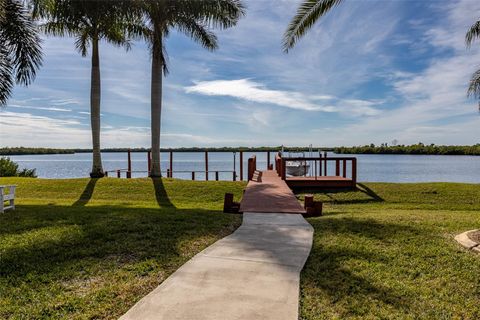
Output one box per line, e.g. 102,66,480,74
308,1,480,145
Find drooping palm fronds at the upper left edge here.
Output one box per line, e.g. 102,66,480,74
0,0,42,105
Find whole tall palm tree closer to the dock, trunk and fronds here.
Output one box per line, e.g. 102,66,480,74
136,0,244,177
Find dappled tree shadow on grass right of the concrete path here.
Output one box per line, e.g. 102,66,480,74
301,217,418,318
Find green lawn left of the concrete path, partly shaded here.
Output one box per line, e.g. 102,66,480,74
0,178,244,319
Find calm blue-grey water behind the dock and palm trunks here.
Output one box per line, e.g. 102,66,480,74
6,152,480,183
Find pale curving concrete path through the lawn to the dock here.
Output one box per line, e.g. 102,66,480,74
120,213,313,320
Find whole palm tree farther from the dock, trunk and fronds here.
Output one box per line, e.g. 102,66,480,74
34,0,130,178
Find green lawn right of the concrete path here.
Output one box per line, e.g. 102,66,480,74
300,183,480,319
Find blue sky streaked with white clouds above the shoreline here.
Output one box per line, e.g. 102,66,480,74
0,0,480,147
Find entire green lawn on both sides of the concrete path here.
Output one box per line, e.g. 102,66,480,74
0,178,480,319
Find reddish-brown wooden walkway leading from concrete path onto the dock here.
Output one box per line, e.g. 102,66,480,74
240,170,305,214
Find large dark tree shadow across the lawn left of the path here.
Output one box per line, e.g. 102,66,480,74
0,205,236,280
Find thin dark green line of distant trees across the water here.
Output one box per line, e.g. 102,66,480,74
0,143,480,156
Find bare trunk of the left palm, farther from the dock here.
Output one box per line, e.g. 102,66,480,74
90,38,105,178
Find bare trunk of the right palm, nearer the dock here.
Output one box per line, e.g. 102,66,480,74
150,36,163,177
